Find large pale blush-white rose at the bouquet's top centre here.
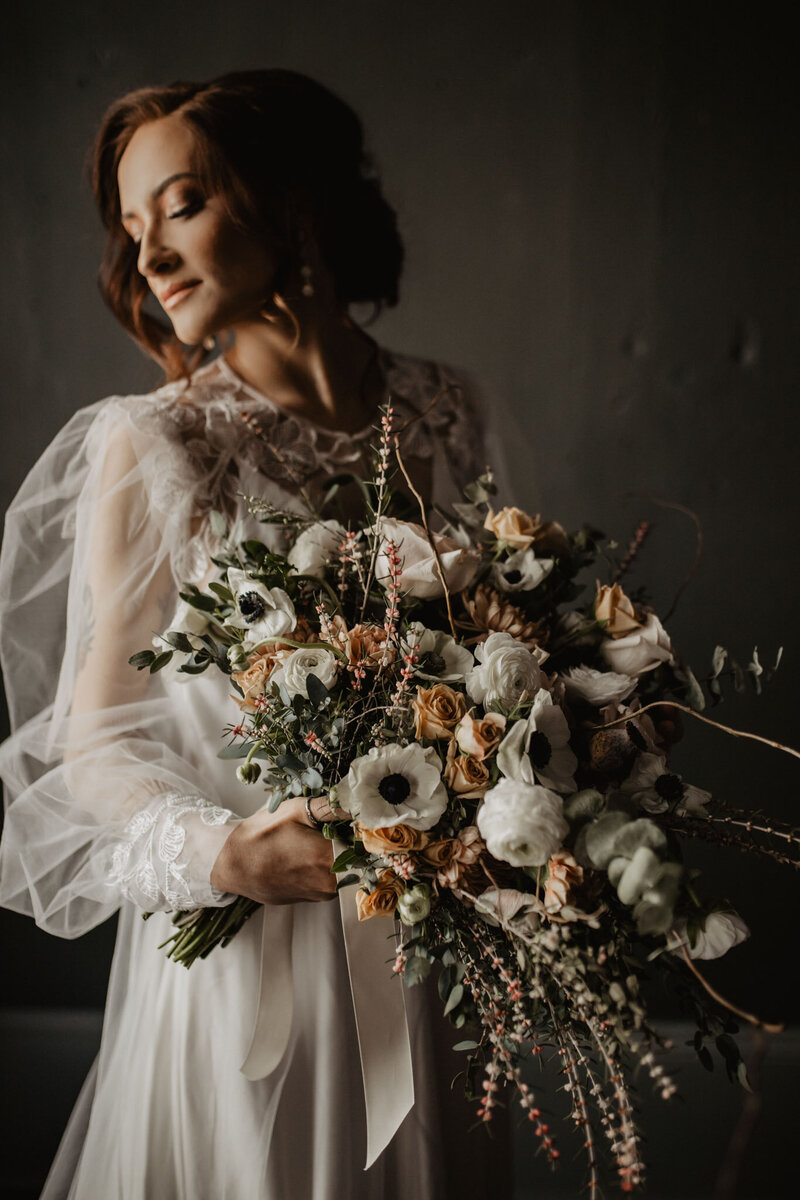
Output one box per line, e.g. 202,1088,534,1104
375,517,481,600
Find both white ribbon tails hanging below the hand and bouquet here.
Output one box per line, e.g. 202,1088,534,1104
241,842,414,1171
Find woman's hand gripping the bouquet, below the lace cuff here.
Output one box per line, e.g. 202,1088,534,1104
211,797,336,904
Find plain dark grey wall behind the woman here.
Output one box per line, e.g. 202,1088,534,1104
0,0,800,1194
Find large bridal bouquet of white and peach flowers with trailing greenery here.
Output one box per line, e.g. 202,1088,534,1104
131,407,796,1196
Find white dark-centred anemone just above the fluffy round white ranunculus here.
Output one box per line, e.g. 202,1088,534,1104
497,688,578,792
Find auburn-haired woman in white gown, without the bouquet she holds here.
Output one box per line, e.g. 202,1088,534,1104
0,71,507,1200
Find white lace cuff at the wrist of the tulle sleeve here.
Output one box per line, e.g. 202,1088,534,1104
106,792,241,912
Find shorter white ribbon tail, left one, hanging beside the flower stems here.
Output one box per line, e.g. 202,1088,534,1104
240,905,294,1079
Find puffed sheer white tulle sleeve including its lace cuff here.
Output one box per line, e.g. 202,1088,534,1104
0,397,236,937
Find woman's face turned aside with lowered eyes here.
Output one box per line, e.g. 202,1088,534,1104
116,113,275,346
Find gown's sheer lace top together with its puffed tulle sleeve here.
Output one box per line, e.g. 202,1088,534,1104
0,350,486,936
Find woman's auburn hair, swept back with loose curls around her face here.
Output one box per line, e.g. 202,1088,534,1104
89,68,403,379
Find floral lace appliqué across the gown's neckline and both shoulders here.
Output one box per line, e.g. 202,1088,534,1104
115,349,486,581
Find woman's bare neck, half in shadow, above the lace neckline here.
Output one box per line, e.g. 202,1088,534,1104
220,306,385,432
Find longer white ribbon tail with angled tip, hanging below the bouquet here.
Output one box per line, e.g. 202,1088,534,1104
339,864,414,1171
